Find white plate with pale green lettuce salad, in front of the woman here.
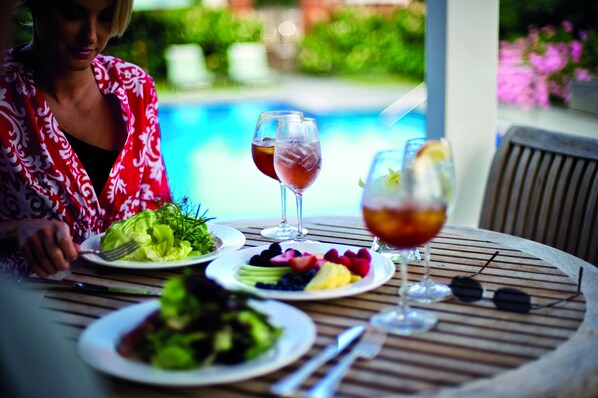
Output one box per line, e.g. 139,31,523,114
81,203,245,269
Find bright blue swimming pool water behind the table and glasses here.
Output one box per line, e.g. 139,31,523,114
159,99,425,222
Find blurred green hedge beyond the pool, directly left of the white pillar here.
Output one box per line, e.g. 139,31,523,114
298,8,425,79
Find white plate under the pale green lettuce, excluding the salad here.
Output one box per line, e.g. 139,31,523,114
81,223,245,269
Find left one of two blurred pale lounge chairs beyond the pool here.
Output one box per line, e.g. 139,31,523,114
165,43,214,89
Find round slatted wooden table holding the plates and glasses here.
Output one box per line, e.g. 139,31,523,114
25,218,598,397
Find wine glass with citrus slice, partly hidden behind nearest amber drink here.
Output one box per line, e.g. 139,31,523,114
404,138,457,303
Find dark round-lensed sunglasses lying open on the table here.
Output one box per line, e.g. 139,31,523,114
449,252,583,314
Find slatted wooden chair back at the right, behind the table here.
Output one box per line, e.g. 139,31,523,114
479,126,598,266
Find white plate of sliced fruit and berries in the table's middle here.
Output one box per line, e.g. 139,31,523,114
206,243,395,300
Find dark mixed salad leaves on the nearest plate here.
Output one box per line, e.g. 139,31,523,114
117,270,282,369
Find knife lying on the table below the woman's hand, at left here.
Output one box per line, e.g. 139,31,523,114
17,278,162,297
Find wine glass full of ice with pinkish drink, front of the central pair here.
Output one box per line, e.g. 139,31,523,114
274,117,322,242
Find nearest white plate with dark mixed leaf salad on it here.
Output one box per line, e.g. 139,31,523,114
78,273,316,387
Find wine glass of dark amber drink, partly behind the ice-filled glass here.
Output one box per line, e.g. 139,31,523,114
251,110,307,240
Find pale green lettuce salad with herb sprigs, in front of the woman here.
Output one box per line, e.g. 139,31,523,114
100,203,216,261
